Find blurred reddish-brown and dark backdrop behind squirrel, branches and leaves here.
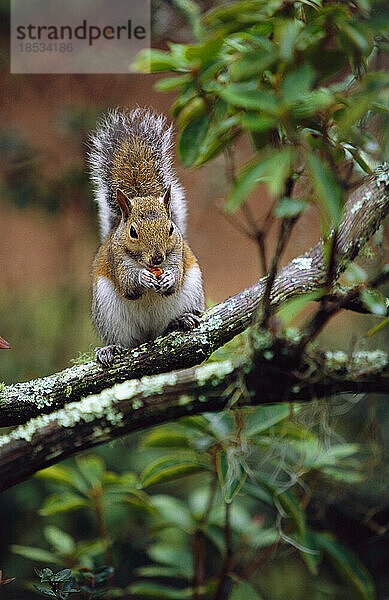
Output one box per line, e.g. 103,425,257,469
0,0,389,600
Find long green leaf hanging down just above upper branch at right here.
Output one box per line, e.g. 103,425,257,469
307,154,342,227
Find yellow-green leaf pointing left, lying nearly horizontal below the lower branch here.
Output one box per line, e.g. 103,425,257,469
140,452,207,487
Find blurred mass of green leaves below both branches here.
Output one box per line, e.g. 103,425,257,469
14,405,373,599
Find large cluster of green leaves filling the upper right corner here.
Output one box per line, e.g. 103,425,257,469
136,0,389,237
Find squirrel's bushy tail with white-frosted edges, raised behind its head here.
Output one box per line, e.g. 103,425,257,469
89,108,186,239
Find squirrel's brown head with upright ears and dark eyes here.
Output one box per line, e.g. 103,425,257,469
116,187,179,268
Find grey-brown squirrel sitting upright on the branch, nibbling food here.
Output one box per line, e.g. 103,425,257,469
89,108,205,366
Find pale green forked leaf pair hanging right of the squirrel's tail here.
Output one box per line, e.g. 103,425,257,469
226,148,293,212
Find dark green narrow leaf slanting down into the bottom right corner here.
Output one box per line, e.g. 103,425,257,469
315,533,375,600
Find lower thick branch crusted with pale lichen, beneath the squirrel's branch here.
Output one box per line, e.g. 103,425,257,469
0,346,389,491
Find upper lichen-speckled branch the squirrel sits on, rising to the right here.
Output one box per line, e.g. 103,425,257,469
0,168,389,427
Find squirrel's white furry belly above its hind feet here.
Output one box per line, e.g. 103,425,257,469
93,266,202,348
